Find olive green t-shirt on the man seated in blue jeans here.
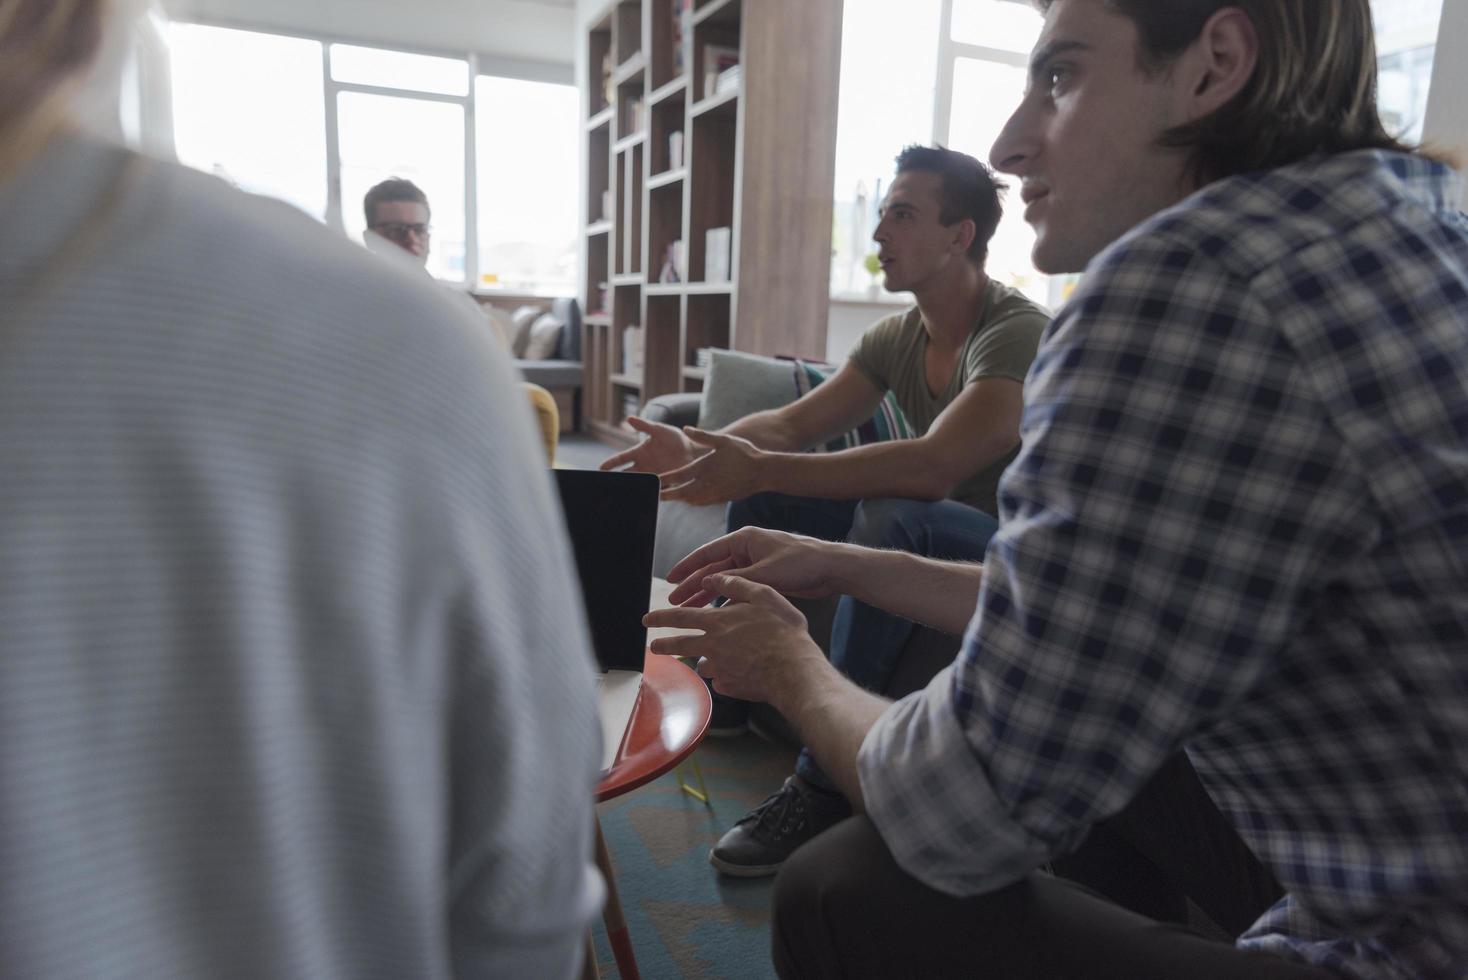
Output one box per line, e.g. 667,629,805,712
849,280,1050,513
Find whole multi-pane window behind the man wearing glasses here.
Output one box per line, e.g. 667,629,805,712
167,23,578,293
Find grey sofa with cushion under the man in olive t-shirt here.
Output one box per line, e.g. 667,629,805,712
642,351,962,738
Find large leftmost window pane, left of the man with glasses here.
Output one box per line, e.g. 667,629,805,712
166,23,326,220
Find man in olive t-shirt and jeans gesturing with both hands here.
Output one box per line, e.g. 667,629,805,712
602,147,1050,877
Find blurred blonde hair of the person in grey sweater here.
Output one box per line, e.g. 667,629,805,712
0,0,107,178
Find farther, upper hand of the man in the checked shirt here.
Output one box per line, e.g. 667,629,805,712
668,527,840,606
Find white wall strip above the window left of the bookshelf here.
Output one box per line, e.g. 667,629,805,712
163,0,575,82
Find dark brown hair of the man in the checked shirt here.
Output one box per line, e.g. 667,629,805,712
1033,0,1411,182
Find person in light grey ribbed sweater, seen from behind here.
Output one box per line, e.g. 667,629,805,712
0,0,602,979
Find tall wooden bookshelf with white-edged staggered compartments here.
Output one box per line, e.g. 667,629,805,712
580,0,841,443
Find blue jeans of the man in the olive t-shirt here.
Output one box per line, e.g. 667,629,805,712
728,493,1000,792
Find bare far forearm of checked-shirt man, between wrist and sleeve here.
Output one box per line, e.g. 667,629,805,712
826,543,984,635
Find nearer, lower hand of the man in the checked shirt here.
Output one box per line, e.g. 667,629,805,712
643,575,829,707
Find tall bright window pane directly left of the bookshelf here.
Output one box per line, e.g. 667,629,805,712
474,75,580,293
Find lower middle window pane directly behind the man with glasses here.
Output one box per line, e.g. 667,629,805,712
336,92,465,282
